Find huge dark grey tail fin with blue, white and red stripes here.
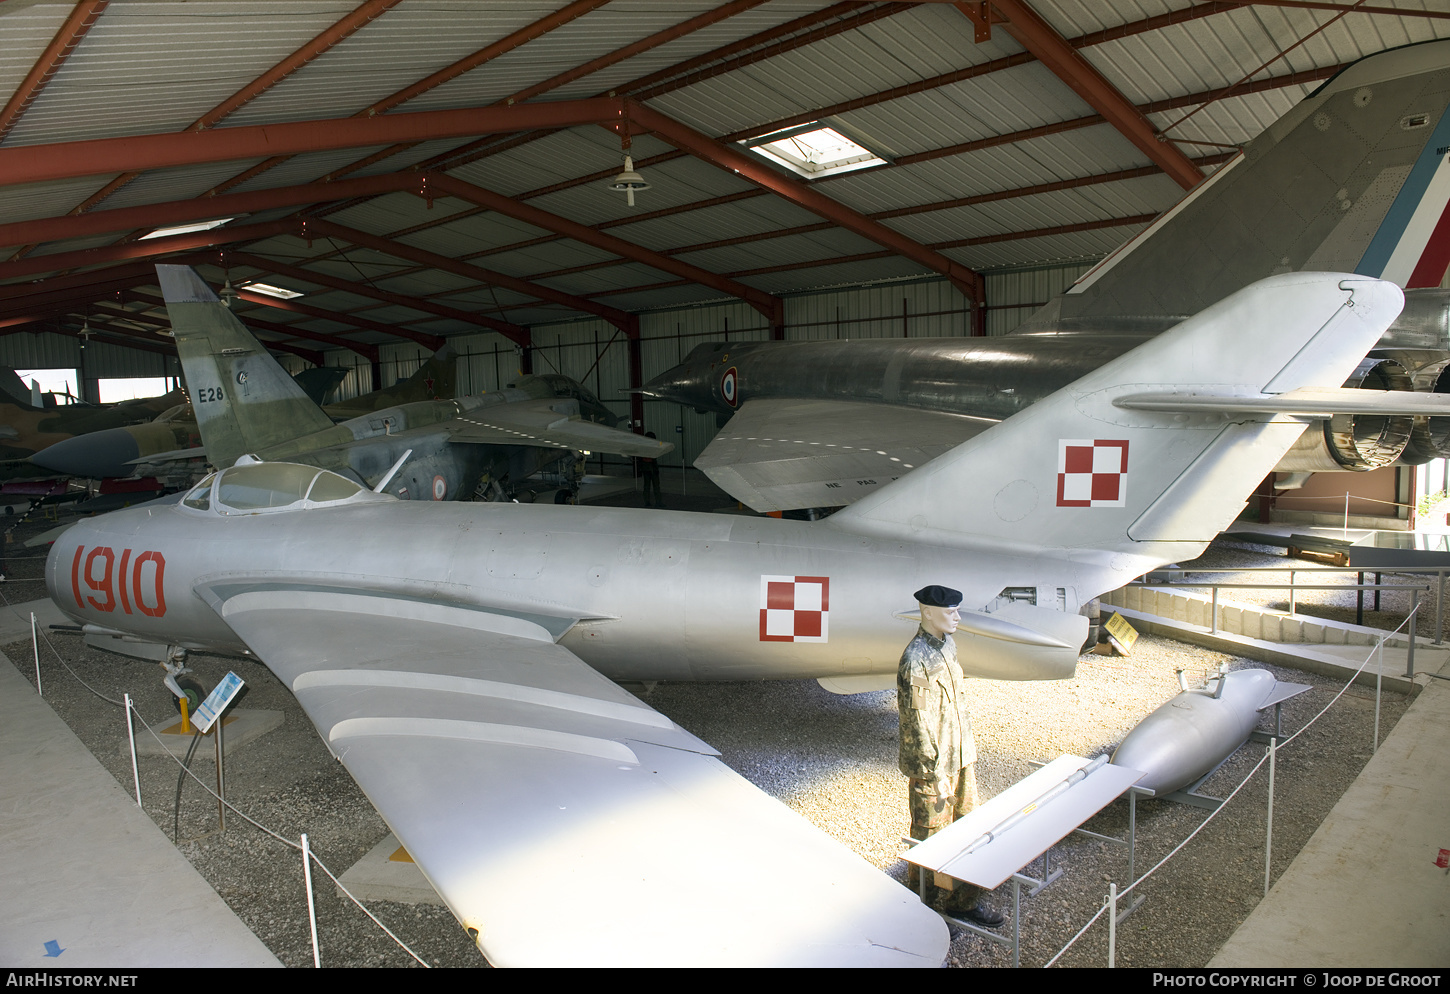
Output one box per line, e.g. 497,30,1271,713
1021,39,1450,333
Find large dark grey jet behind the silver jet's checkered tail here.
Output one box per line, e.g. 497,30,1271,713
644,41,1450,511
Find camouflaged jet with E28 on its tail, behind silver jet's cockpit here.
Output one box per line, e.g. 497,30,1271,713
148,265,673,500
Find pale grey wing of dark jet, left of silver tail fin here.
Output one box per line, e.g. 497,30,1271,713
695,398,996,511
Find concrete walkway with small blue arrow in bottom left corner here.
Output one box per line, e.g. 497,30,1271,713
0,646,281,969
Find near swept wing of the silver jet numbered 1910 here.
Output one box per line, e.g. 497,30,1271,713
213,590,948,966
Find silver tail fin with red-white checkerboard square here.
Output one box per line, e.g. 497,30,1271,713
828,272,1404,568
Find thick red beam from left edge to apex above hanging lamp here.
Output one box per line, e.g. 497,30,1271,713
0,97,622,185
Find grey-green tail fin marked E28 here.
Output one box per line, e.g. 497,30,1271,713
157,265,332,468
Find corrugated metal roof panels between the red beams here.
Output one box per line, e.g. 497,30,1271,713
0,0,1450,360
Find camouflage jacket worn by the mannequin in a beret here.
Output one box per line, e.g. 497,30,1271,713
896,629,977,781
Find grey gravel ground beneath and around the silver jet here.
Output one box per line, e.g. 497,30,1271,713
0,501,1407,966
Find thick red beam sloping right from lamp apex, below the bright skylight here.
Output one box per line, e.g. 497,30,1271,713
629,100,980,300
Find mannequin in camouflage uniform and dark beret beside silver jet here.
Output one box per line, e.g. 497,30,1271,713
896,585,1003,927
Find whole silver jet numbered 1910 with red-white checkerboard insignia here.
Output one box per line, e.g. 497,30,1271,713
46,274,1402,966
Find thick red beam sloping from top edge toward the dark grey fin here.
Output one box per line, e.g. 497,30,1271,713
986,0,1204,190
